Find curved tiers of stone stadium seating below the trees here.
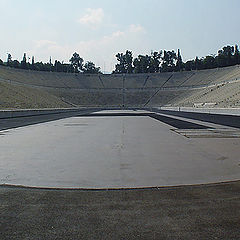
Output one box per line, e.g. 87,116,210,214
0,65,240,107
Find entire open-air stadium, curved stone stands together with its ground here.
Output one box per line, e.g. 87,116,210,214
0,65,240,239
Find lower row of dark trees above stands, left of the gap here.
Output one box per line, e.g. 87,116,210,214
0,52,101,74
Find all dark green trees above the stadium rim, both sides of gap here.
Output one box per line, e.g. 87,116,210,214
0,45,240,74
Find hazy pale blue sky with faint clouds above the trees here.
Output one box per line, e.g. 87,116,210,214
0,0,240,72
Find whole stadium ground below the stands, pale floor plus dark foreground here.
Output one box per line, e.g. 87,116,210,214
0,110,240,240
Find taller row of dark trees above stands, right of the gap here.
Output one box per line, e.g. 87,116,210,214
113,45,240,74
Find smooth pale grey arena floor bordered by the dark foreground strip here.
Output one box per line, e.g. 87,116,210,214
0,111,240,189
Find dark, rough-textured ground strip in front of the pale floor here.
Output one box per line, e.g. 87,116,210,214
0,182,240,240
